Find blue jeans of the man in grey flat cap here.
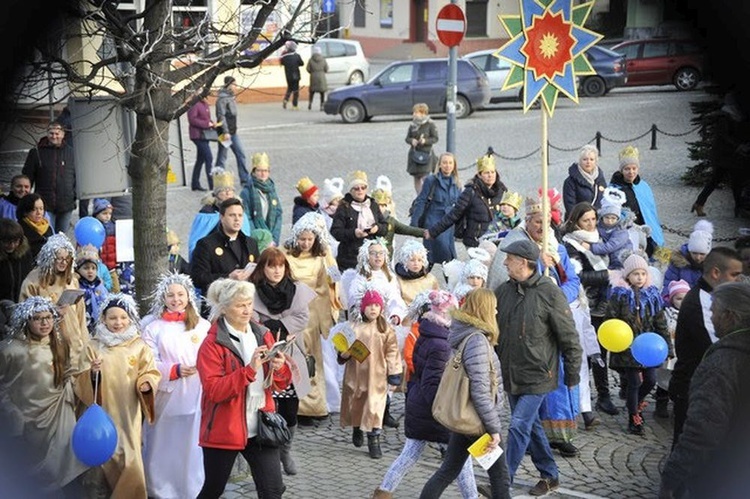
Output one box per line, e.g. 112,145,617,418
505,394,558,481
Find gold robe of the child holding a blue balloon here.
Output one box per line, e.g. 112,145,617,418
76,337,161,499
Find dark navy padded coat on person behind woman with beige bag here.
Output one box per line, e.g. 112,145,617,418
404,319,451,443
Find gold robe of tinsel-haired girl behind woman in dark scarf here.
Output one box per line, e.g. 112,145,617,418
287,253,335,417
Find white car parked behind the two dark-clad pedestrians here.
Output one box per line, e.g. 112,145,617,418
300,38,370,88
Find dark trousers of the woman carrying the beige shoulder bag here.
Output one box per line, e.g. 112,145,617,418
419,432,511,499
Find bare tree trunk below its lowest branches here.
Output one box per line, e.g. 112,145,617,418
128,115,169,315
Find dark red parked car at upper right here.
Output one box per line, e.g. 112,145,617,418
612,38,705,90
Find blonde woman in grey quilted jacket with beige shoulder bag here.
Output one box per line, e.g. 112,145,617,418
419,288,511,499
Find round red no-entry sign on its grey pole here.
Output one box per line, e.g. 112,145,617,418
435,0,466,154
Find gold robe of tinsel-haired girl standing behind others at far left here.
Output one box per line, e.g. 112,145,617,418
19,268,89,370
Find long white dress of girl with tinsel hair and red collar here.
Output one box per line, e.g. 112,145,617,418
141,319,211,499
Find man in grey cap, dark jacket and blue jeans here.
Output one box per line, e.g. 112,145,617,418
495,239,582,496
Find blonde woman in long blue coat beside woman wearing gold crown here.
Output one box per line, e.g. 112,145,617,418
410,152,461,266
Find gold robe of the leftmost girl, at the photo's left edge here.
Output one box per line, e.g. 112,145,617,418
0,333,87,488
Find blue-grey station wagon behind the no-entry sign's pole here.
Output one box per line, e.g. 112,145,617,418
324,58,490,123
